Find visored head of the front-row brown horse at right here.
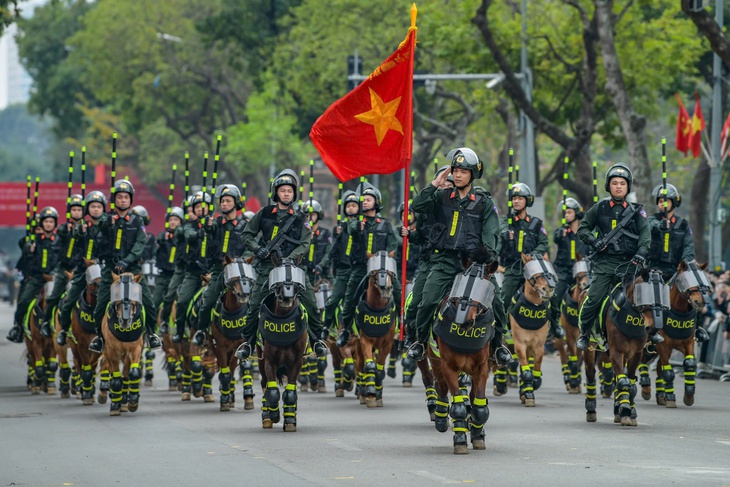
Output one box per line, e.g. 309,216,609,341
623,269,669,327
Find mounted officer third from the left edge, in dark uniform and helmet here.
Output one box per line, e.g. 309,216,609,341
56,191,110,346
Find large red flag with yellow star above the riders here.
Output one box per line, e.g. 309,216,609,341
309,4,417,181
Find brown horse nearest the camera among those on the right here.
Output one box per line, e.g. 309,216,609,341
584,269,669,426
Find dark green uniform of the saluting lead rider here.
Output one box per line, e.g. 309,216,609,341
411,184,507,343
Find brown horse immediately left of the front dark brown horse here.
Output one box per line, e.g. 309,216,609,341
211,256,256,412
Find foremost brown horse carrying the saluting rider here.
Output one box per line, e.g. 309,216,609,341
430,249,497,455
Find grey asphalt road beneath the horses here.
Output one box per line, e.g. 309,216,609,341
0,303,730,487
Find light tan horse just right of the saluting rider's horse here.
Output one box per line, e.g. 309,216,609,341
509,254,558,407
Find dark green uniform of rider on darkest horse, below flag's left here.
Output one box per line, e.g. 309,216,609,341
243,205,322,343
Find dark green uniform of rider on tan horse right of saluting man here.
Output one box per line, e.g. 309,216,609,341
499,215,550,312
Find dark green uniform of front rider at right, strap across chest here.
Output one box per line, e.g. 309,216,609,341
578,198,651,340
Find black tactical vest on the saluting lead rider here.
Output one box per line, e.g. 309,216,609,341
431,189,488,252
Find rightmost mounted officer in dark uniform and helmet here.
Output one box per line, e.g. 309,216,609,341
649,184,710,342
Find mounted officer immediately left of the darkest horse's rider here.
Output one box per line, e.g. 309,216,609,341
192,184,246,347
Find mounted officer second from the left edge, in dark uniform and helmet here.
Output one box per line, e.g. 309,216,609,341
41,194,84,337
